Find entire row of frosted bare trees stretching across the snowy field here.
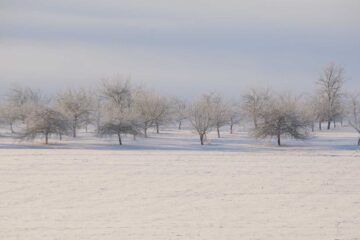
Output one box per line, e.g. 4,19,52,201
0,64,360,145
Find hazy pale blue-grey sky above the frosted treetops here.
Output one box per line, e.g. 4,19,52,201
0,0,360,97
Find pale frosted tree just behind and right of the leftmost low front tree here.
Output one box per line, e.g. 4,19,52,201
56,89,93,138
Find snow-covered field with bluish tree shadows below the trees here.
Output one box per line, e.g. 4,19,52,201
0,126,360,240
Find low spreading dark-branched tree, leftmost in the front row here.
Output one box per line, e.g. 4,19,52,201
22,106,70,144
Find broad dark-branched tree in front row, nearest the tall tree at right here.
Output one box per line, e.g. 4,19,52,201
253,95,309,146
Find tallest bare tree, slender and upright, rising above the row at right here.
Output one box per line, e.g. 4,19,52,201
317,63,344,129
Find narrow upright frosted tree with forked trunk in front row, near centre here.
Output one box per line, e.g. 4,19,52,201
188,95,214,145
